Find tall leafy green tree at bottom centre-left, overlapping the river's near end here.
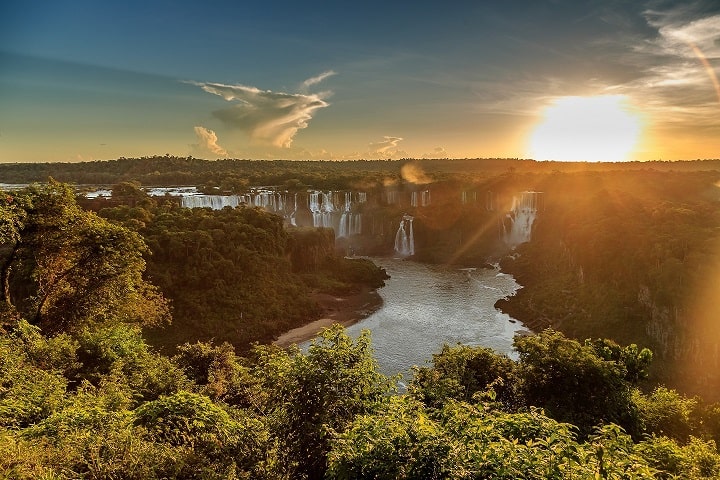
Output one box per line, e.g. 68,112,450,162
255,325,390,479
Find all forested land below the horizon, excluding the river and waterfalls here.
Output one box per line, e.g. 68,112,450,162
0,156,720,479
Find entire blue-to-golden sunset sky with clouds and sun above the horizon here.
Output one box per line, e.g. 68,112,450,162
0,0,720,162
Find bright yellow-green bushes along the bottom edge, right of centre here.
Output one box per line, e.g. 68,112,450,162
328,397,654,479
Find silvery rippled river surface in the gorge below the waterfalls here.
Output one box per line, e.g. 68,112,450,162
303,258,525,378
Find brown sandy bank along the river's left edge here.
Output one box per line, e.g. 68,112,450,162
273,288,383,347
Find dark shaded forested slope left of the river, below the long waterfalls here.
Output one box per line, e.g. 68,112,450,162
100,184,387,350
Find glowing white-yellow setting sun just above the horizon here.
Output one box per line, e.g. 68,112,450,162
528,95,641,162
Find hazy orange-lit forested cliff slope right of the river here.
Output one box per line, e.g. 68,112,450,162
500,171,720,398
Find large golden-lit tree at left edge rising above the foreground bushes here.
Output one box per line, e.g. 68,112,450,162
3,181,169,333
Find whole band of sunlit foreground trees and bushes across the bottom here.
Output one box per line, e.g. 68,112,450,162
0,316,720,479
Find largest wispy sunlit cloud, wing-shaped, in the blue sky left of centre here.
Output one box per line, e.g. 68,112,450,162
191,71,335,148
